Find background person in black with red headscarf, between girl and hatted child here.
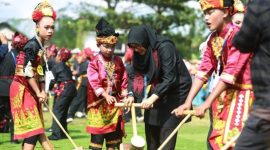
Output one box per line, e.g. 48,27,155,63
48,48,77,140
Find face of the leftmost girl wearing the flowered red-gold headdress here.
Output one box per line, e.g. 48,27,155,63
36,16,54,41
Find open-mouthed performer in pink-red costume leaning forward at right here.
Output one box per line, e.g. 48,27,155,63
173,0,254,149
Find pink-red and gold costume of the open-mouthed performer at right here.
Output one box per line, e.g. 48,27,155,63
196,24,254,149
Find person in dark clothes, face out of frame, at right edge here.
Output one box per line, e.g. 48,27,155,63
233,0,270,150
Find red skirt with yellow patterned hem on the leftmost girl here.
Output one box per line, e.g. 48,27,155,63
10,79,44,139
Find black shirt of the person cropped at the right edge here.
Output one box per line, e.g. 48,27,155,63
233,0,270,109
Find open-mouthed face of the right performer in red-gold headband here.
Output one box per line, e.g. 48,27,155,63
204,9,228,31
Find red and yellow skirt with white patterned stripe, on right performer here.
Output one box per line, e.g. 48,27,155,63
209,89,254,150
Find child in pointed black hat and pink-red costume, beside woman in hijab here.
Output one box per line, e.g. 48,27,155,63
86,18,127,150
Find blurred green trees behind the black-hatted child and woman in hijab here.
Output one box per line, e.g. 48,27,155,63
53,0,207,59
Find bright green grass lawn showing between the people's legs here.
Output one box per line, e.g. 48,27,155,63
0,108,209,150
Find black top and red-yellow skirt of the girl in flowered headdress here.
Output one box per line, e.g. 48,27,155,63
10,38,44,139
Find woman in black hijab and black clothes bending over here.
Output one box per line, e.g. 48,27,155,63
126,25,191,150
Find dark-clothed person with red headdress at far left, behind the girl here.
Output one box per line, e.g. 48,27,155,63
0,32,28,143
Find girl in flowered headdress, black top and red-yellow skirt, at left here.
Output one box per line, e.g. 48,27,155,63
10,1,56,150
